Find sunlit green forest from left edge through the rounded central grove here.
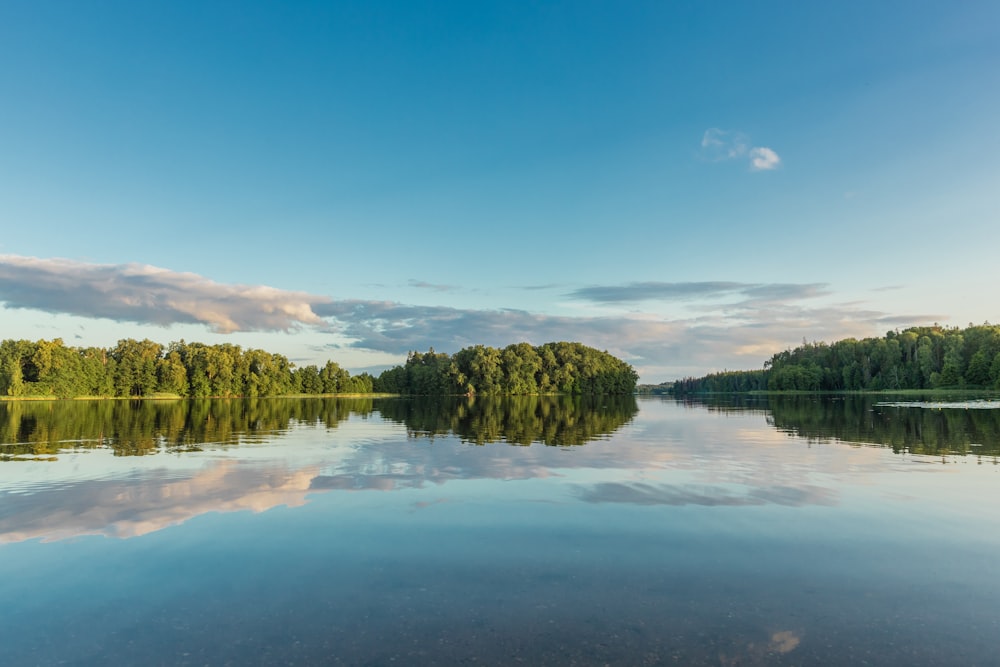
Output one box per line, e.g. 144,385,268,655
0,338,636,398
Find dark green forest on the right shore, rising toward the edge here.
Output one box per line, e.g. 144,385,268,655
673,324,1000,394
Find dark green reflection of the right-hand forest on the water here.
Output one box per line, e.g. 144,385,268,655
682,394,1000,457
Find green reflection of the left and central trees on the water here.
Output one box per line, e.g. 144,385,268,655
0,396,638,461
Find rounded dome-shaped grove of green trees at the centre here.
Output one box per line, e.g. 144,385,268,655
375,342,638,395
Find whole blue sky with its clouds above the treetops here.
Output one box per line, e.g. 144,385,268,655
0,2,1000,382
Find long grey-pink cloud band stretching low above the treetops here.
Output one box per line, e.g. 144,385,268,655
0,255,947,381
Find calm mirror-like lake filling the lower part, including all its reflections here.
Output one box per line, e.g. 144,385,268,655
0,396,1000,666
